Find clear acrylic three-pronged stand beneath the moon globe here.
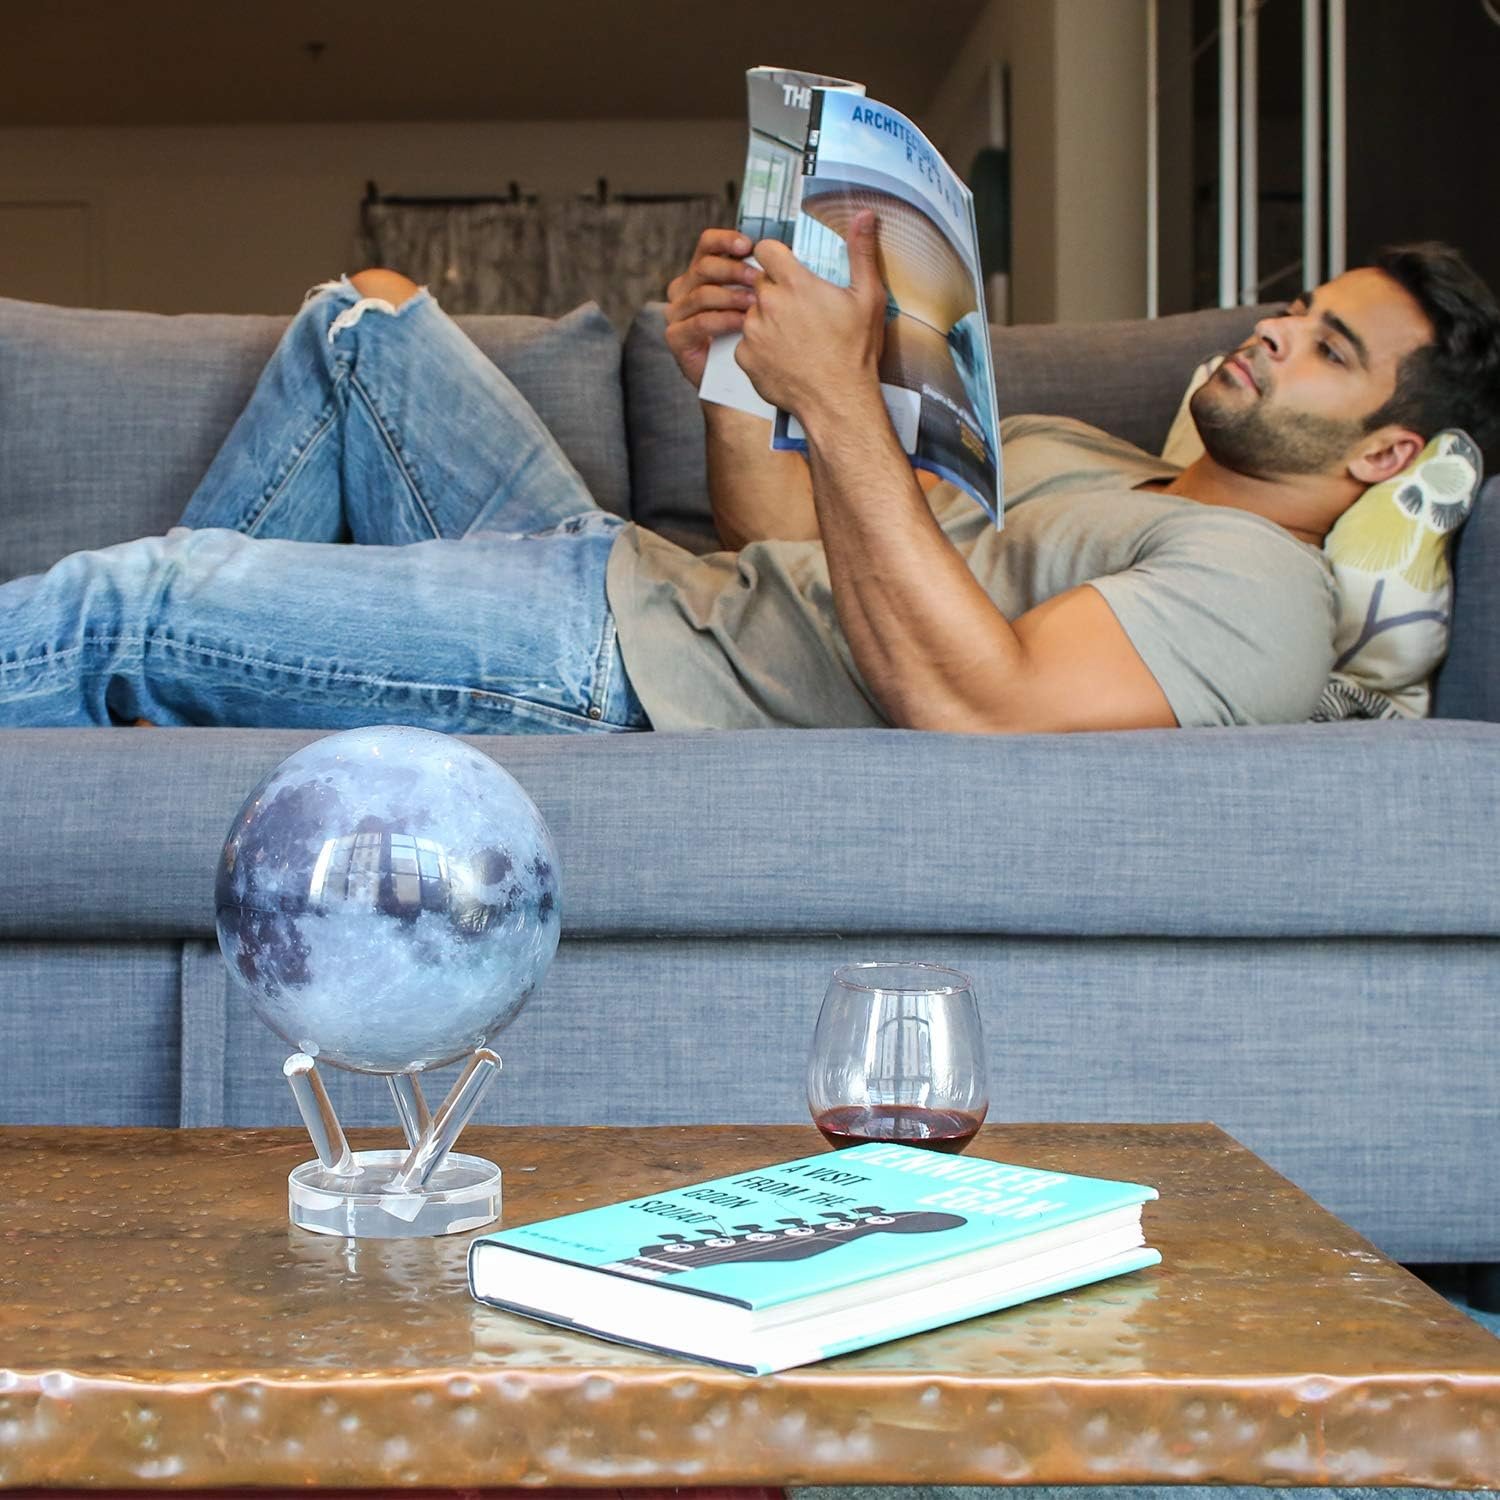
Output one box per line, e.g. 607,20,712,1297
282,1047,501,1239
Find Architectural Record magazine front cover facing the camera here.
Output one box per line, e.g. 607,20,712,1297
773,90,1001,525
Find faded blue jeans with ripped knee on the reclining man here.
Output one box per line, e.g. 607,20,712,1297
0,279,650,734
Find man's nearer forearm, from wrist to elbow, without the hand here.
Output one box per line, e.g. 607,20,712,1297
804,389,1026,729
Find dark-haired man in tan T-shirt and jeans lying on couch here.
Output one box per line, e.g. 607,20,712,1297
0,218,1500,734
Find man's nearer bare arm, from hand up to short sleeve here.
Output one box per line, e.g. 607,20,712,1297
735,219,1178,734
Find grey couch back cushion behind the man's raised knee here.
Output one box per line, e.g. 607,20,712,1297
0,299,630,581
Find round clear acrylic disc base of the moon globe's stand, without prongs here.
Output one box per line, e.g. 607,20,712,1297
287,1151,500,1239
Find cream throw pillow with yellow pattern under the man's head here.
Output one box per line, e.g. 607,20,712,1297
1161,359,1484,720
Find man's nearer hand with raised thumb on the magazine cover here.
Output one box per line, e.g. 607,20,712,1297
735,209,887,428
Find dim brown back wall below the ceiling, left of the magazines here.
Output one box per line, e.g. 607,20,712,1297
0,119,744,312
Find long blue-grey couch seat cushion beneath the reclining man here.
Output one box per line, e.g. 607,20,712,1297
0,720,1500,947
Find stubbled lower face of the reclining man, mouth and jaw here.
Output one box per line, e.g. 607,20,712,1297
1188,344,1365,479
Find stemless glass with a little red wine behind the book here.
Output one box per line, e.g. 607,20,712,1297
807,963,990,1152
